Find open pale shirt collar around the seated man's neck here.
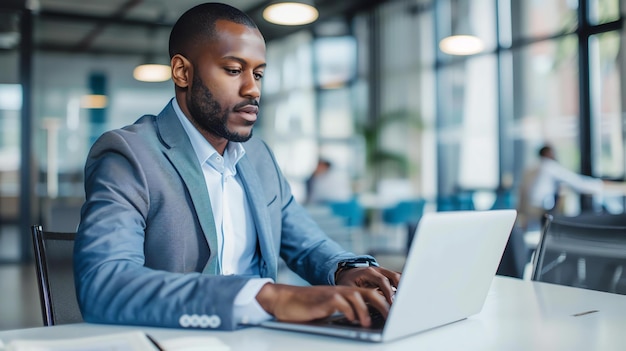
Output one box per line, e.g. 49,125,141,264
172,98,246,174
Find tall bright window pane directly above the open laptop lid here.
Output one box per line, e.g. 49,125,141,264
438,55,499,194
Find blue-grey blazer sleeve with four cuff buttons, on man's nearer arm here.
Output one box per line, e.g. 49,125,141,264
74,131,248,330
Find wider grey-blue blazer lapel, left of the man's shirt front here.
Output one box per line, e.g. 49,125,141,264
155,102,221,274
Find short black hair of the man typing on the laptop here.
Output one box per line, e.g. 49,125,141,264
169,2,258,58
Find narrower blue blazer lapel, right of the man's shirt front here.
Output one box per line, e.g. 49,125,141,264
237,156,278,280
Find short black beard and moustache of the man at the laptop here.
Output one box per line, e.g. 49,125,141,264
187,75,258,143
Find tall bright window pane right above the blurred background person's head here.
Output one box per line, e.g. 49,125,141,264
514,35,580,167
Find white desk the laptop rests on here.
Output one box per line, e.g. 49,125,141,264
0,277,626,351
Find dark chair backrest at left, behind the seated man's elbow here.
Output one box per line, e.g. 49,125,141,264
31,226,83,326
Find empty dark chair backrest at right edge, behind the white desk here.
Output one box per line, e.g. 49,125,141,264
531,215,626,294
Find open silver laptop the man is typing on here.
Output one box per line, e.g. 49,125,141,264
262,210,516,342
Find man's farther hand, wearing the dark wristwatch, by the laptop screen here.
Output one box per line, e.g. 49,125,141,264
335,267,401,304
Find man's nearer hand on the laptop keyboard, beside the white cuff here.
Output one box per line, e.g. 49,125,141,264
256,284,389,327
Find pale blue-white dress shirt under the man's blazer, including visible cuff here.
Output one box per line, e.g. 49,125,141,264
172,99,273,324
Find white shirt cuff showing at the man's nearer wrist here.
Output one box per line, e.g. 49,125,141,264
233,278,274,325
